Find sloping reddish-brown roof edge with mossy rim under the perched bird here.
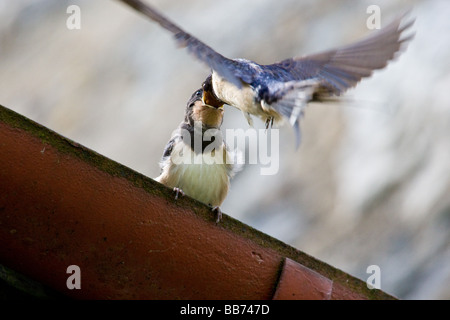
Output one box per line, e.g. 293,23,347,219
0,106,394,299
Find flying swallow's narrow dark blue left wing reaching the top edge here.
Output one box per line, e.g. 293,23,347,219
120,0,252,88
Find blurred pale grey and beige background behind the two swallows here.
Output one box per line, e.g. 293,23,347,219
0,0,450,299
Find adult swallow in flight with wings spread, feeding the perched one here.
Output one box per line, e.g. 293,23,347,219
117,0,414,146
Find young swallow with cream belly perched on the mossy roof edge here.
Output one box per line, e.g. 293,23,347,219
155,89,241,222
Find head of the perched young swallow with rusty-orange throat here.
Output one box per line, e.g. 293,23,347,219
185,89,223,128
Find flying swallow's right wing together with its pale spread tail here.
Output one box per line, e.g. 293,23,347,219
259,15,414,147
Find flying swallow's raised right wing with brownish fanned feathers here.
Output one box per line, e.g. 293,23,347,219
266,11,414,95
